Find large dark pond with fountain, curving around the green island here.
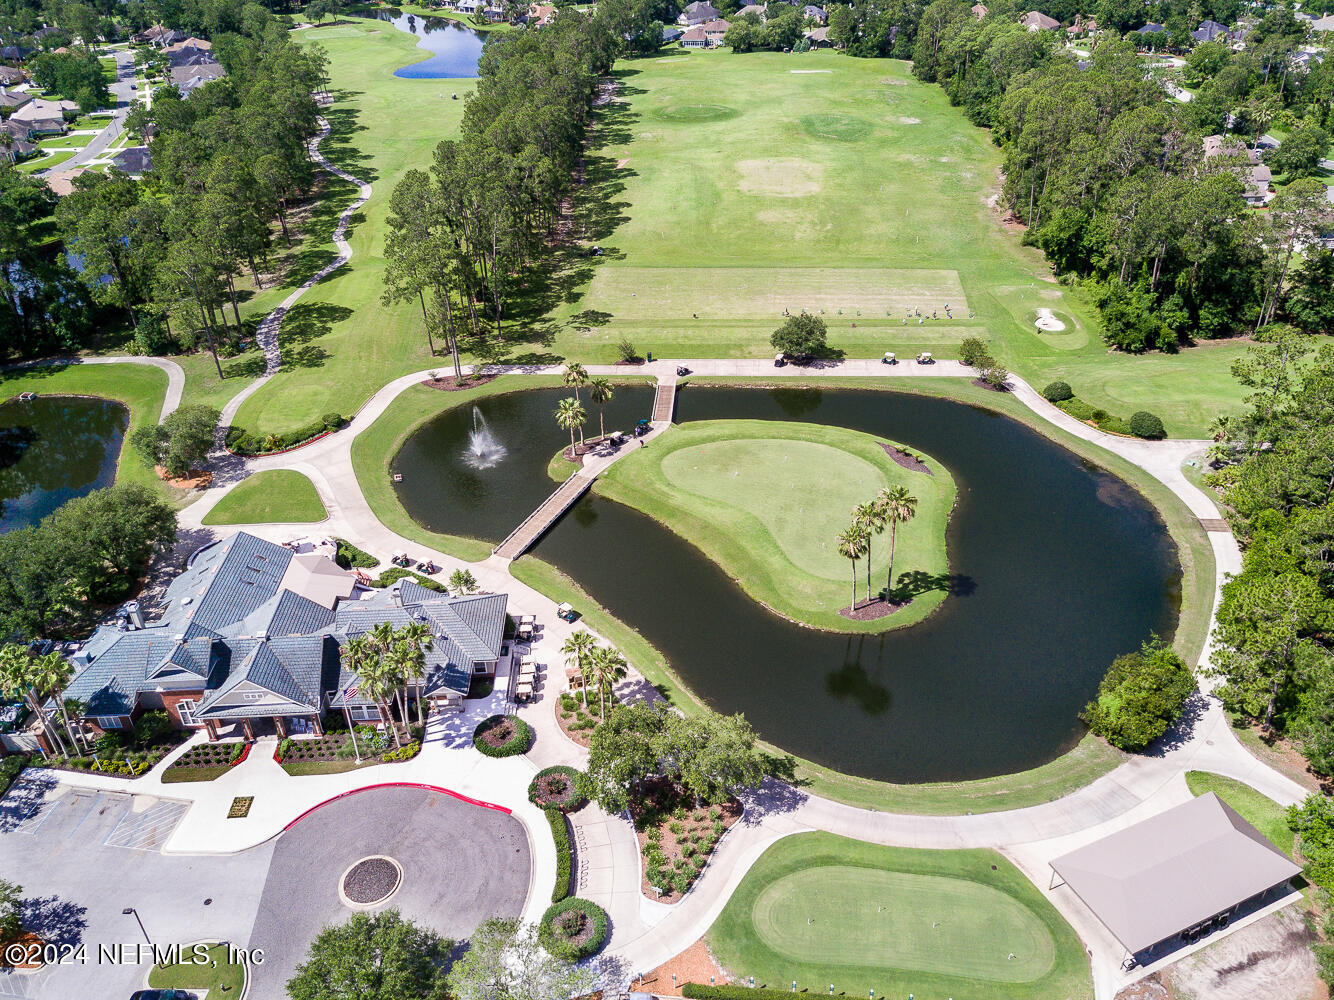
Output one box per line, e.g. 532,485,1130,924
395,388,1181,781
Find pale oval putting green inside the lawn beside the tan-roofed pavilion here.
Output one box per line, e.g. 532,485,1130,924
752,865,1057,983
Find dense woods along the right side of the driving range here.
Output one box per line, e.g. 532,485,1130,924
912,0,1331,351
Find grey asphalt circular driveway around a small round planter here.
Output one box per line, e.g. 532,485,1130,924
249,788,531,1000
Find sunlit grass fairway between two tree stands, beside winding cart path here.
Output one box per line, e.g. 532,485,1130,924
233,20,475,435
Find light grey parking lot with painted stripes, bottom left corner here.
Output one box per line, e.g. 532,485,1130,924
0,772,273,1000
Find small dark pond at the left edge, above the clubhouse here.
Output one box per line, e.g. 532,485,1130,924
0,396,129,532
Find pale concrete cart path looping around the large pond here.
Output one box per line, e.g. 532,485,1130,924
158,359,1305,1000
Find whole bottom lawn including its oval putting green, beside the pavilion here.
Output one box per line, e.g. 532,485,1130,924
707,833,1093,1000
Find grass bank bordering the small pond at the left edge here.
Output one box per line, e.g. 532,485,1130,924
0,364,172,500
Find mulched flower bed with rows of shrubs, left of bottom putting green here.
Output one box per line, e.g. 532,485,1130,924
630,780,742,903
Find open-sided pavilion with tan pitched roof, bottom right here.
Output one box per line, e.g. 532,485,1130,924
1051,792,1302,956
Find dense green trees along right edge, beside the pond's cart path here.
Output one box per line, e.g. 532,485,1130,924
1210,341,1334,775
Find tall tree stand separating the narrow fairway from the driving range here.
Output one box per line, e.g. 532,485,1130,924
384,11,618,375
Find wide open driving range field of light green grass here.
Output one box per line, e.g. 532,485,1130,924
538,51,1269,436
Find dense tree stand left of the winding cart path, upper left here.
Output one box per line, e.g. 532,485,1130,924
48,4,324,375
